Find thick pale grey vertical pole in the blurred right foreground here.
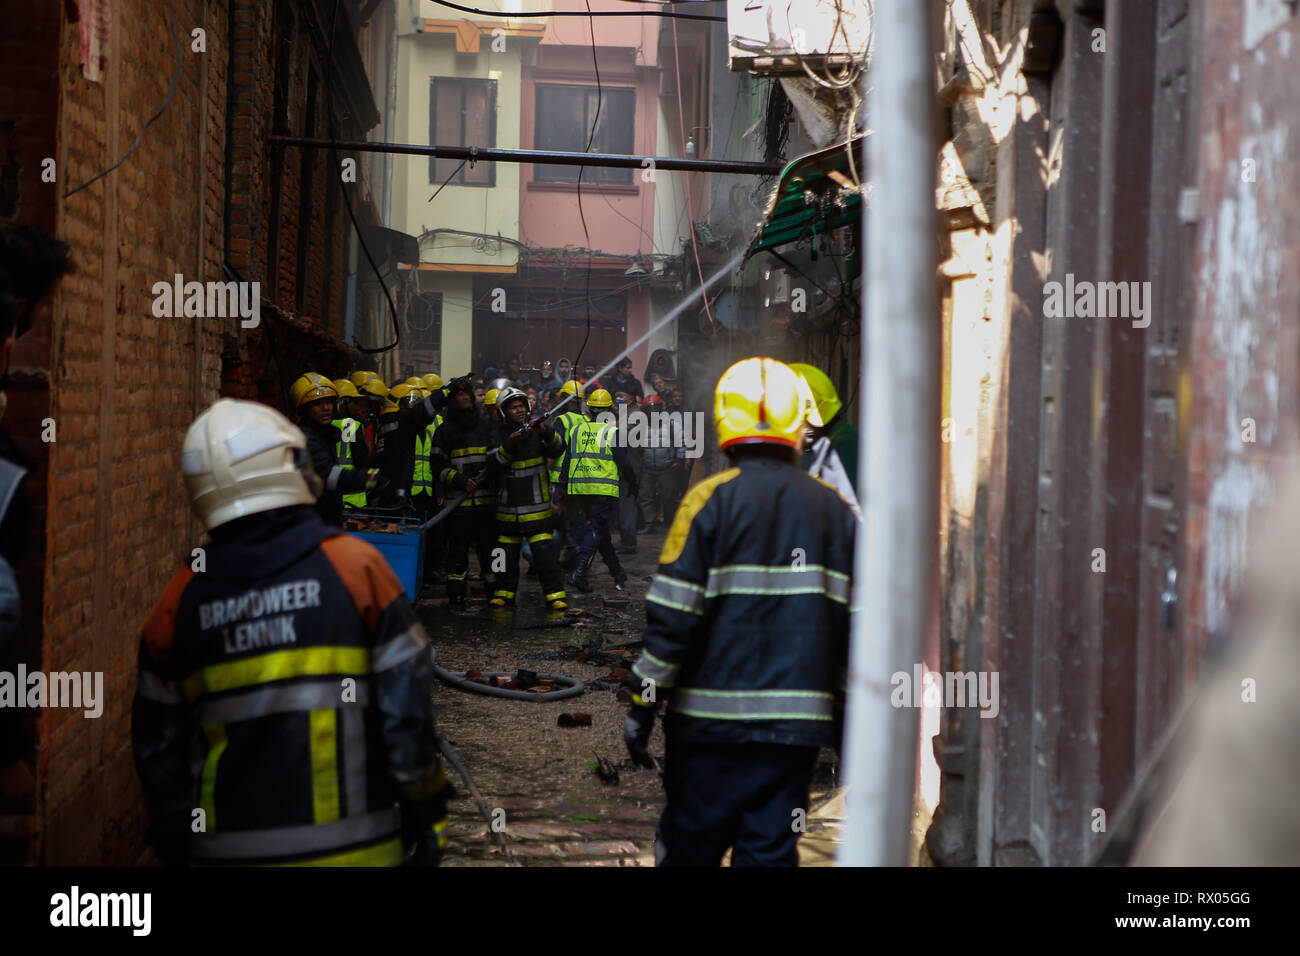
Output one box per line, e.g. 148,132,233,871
839,0,941,866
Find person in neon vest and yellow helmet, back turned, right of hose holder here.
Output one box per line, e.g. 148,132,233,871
564,389,637,594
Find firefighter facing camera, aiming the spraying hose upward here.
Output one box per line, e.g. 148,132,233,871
488,388,568,611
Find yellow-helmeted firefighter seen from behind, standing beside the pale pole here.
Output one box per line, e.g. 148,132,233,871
624,358,855,866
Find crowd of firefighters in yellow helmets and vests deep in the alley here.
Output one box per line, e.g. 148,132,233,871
290,361,676,611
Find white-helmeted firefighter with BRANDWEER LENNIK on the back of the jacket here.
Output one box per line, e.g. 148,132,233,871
131,398,446,866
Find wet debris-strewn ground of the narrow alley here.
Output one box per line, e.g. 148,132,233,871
417,522,842,866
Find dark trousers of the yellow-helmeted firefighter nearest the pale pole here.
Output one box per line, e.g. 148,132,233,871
655,737,816,866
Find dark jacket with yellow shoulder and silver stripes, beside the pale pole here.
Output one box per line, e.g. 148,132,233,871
632,458,855,747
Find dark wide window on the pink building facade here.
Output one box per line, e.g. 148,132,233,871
534,83,637,185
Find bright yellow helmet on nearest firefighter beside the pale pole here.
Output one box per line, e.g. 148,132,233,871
714,358,813,449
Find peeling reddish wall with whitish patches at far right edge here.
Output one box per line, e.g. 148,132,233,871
1183,0,1300,676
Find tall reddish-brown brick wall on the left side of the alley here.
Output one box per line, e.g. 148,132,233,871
38,0,225,864
